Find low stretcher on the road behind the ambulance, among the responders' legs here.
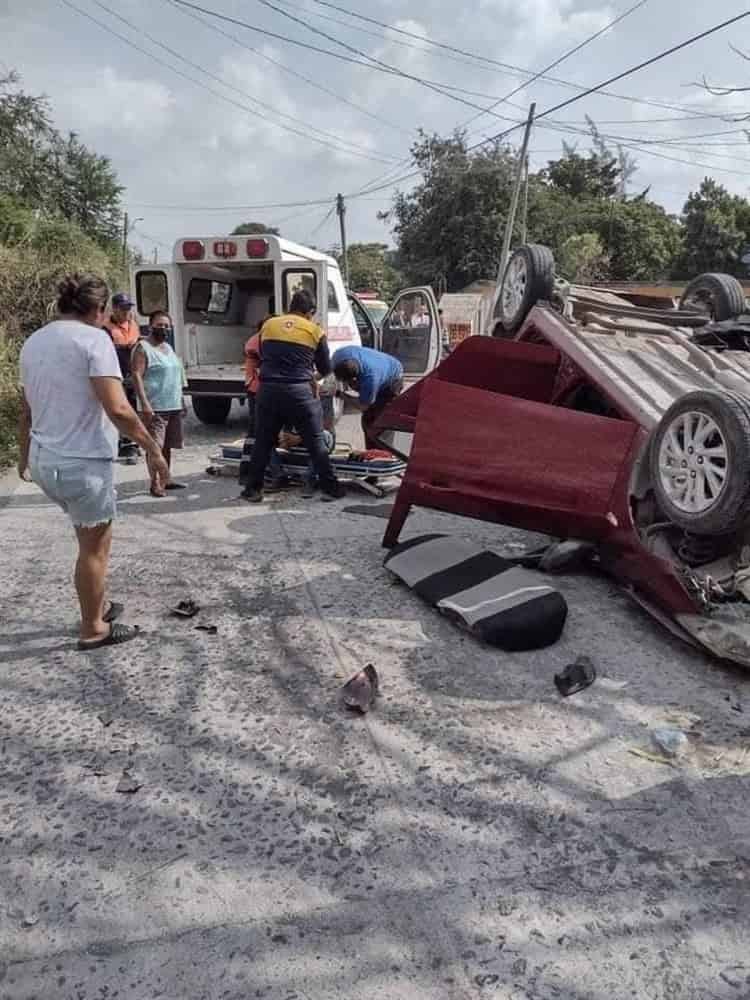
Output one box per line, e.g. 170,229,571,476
206,442,406,498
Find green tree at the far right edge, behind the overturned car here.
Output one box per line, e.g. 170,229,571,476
675,177,750,278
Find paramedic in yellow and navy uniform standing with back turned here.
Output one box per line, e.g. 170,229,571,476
241,289,343,503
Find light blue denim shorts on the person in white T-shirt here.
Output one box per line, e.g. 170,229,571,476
29,441,117,528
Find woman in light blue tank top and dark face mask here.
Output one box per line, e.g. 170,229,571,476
130,311,185,497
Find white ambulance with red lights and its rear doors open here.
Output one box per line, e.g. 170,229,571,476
132,235,373,424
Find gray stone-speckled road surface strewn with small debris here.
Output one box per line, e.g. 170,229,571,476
0,402,750,1000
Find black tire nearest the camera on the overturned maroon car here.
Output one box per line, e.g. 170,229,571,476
649,389,750,536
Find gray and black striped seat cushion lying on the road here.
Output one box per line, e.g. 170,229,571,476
384,535,568,651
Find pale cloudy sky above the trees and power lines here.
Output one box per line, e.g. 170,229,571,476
0,0,750,259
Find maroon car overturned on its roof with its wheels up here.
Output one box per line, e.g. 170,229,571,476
376,247,750,667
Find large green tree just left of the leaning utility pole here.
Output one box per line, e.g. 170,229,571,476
388,133,514,291
